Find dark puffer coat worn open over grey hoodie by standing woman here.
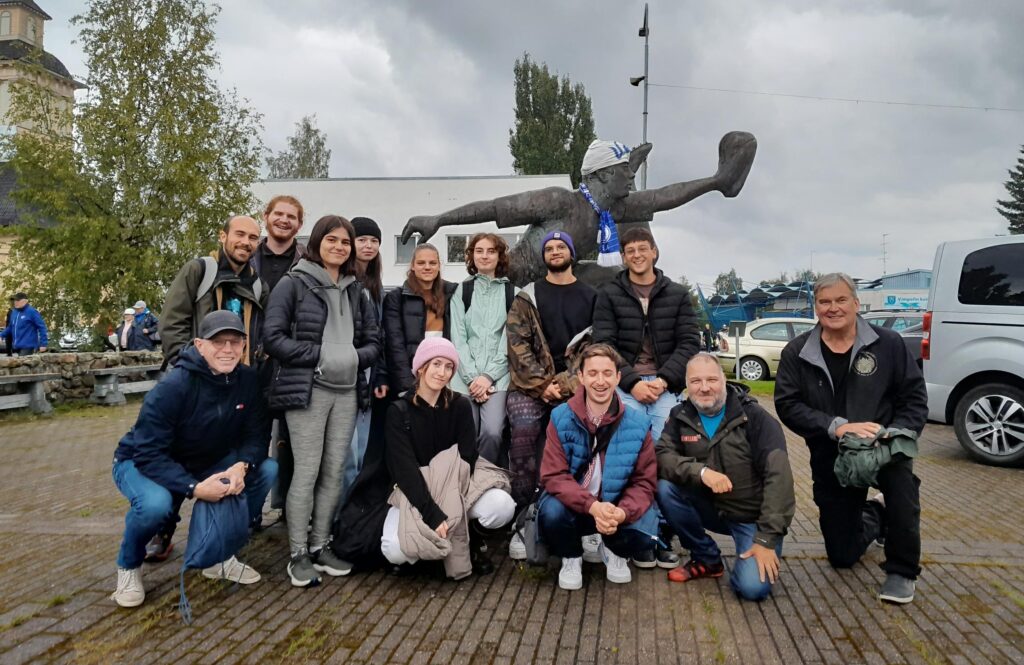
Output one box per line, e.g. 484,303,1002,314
263,272,381,411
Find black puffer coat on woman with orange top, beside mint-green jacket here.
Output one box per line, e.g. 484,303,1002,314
384,282,458,394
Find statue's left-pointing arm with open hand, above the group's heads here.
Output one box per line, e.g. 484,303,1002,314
401,188,572,243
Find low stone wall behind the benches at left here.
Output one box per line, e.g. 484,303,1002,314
0,351,164,404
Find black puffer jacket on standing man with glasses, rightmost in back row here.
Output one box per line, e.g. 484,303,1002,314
594,268,700,392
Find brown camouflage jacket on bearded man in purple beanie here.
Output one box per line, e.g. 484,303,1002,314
505,284,580,400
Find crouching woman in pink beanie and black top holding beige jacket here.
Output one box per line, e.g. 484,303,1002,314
332,337,515,579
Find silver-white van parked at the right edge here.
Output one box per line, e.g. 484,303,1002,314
922,236,1024,466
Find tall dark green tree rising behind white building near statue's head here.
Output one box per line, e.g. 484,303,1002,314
509,53,597,186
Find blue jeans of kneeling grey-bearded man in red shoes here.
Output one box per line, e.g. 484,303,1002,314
657,480,782,600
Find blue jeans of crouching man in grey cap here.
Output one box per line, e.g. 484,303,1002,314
113,452,278,570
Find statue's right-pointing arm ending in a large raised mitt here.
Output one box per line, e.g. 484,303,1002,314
625,131,758,219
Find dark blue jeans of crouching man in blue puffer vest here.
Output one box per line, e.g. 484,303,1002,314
537,494,651,558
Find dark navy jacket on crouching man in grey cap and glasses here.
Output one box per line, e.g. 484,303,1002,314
114,346,267,496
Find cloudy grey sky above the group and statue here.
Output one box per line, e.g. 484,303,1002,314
39,0,1024,291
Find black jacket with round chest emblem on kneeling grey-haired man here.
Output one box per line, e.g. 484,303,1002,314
775,317,928,450
